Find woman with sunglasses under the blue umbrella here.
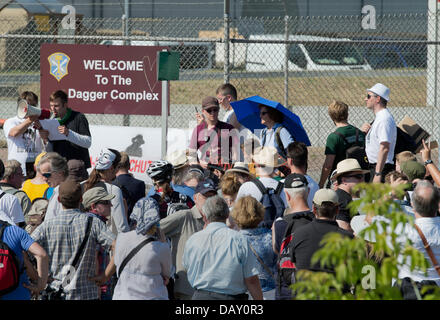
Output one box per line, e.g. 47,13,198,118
259,104,295,159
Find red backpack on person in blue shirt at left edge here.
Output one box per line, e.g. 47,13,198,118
0,221,21,296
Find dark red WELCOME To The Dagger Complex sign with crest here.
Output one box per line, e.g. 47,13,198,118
40,44,169,115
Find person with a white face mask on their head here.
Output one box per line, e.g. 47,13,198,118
83,148,130,234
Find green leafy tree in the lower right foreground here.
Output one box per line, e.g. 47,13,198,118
291,184,440,300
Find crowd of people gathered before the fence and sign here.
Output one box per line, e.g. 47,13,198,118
0,83,440,300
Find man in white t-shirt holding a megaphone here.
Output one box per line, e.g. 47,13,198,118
3,91,50,179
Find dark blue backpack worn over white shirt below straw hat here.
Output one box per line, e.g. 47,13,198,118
251,179,286,229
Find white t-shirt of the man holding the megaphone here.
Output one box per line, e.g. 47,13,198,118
3,117,43,175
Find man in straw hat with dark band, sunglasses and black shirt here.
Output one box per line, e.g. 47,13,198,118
332,158,369,231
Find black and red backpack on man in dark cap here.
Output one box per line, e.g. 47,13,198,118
275,212,313,299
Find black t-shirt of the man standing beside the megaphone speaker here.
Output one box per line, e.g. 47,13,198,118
51,110,92,168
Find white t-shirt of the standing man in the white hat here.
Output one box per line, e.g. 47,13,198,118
365,108,397,164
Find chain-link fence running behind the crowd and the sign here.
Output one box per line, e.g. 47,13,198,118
0,13,440,177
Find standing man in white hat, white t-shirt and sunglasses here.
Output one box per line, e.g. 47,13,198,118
361,83,397,182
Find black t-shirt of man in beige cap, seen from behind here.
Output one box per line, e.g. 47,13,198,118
290,219,353,272
